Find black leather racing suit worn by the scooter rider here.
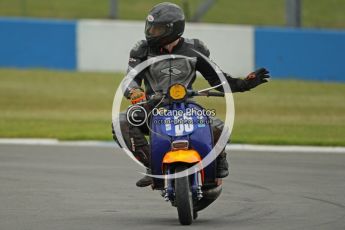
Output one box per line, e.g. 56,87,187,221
113,38,249,166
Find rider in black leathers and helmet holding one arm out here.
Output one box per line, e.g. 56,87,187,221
113,2,270,187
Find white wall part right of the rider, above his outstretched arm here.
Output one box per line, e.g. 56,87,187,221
184,24,254,77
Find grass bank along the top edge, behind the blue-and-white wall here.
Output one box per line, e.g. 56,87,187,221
0,0,345,28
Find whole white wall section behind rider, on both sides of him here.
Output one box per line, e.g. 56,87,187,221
77,20,254,76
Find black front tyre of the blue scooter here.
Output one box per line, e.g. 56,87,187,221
175,165,193,225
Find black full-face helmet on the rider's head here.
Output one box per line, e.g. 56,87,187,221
145,2,185,47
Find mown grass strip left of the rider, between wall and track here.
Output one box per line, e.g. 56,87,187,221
0,70,119,139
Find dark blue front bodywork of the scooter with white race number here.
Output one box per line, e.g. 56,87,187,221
150,103,215,187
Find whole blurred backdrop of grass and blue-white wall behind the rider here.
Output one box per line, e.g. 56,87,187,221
0,0,345,146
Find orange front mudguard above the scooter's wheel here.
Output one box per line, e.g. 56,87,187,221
163,149,201,164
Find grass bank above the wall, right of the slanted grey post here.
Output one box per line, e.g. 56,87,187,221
204,0,345,28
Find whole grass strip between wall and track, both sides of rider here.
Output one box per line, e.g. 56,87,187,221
0,69,345,146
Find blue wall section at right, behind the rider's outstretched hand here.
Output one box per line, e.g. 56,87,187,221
255,28,345,81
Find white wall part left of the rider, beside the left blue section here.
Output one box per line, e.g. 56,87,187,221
77,20,144,72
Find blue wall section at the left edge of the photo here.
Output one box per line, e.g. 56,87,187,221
0,18,77,70
